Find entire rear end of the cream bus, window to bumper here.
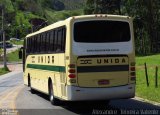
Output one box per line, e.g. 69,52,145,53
67,16,135,100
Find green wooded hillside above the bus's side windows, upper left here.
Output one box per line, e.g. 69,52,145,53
0,0,85,39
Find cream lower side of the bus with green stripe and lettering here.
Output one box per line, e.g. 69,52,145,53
24,53,66,98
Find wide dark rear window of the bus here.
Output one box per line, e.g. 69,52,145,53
74,20,131,43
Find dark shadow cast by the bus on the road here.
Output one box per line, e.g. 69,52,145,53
31,92,160,115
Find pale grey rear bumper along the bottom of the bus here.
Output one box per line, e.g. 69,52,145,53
67,84,135,101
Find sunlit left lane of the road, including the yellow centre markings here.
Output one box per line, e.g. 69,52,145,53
0,72,23,109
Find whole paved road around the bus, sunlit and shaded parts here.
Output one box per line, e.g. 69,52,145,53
0,72,160,115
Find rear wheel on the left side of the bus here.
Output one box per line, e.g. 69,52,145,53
49,82,59,105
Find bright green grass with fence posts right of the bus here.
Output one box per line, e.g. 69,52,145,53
136,54,160,102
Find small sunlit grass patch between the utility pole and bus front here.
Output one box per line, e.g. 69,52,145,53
7,50,22,62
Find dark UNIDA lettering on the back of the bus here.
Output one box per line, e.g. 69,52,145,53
97,58,126,64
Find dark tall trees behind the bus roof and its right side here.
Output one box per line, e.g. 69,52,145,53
84,0,160,55
